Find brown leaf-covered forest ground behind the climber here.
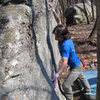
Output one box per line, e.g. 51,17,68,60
60,21,97,100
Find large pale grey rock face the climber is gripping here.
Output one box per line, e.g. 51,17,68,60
0,0,65,100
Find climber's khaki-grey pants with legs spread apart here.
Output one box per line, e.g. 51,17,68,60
63,64,90,100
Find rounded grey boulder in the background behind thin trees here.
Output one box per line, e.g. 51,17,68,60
64,3,96,24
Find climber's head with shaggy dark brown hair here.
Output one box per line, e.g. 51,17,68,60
53,24,71,40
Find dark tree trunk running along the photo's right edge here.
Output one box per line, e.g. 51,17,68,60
96,0,100,100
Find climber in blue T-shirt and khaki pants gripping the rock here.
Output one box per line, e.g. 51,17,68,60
49,3,90,100
